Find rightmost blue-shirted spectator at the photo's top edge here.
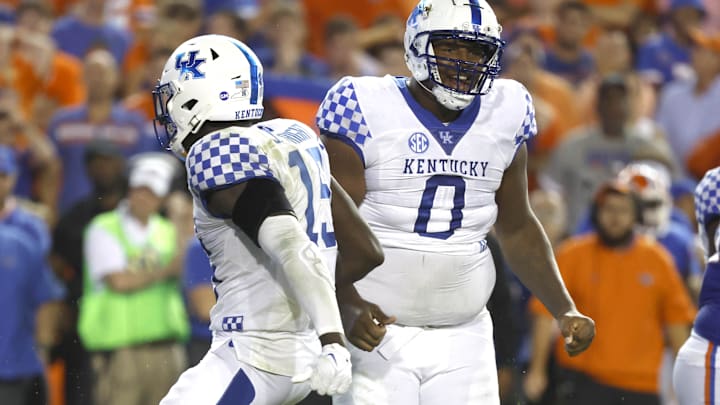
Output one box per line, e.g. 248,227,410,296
635,0,706,87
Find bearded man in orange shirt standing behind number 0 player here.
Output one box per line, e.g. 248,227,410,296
525,181,695,405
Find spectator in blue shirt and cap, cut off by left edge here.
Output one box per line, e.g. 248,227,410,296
0,152,64,405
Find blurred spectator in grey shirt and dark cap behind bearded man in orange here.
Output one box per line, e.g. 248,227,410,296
540,74,673,230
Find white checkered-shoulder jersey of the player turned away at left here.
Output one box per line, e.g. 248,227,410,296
186,119,336,375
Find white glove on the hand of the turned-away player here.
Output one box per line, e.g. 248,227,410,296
292,343,352,395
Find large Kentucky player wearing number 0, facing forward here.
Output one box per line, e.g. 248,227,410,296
316,0,595,405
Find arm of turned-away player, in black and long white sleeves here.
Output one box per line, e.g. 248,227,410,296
206,179,344,346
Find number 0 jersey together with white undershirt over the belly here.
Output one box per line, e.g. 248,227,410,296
316,76,537,325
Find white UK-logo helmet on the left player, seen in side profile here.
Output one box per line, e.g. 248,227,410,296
153,35,264,159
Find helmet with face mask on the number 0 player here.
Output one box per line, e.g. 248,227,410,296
405,0,505,110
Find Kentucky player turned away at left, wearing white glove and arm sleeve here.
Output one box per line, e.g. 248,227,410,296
153,35,382,405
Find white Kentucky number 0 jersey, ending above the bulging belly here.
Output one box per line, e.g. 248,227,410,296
317,76,536,254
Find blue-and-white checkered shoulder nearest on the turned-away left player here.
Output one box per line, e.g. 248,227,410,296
186,132,275,192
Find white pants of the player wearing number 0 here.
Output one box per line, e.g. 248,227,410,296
333,308,500,405
